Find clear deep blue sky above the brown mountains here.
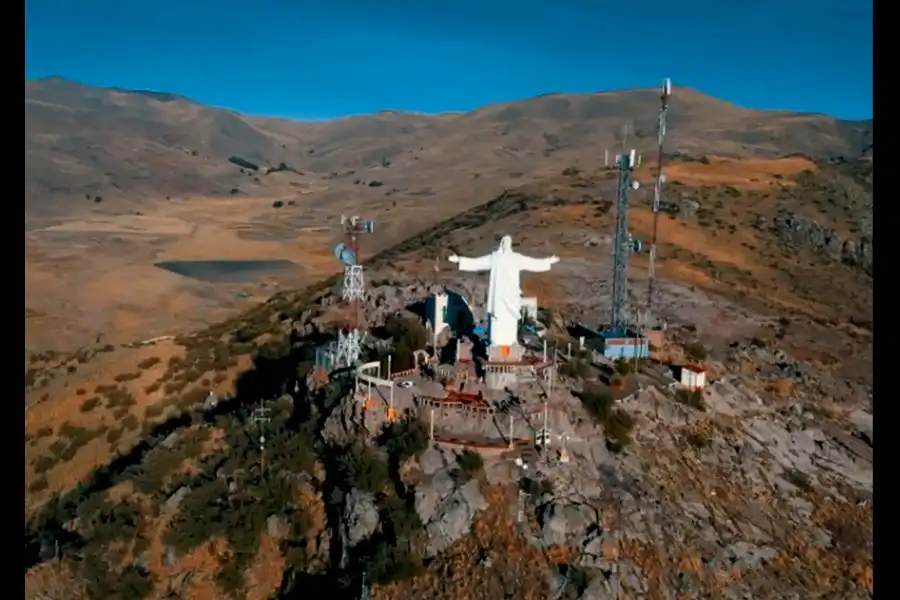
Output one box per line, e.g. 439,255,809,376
25,0,873,119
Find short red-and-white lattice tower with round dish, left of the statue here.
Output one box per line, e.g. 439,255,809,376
334,215,375,368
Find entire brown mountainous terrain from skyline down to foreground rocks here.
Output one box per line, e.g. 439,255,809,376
25,80,874,600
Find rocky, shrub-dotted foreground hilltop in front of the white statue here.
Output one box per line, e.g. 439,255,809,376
26,281,874,600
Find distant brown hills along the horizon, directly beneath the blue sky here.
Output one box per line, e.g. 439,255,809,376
25,78,872,215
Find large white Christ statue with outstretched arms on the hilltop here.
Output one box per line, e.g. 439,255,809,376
449,235,559,346
